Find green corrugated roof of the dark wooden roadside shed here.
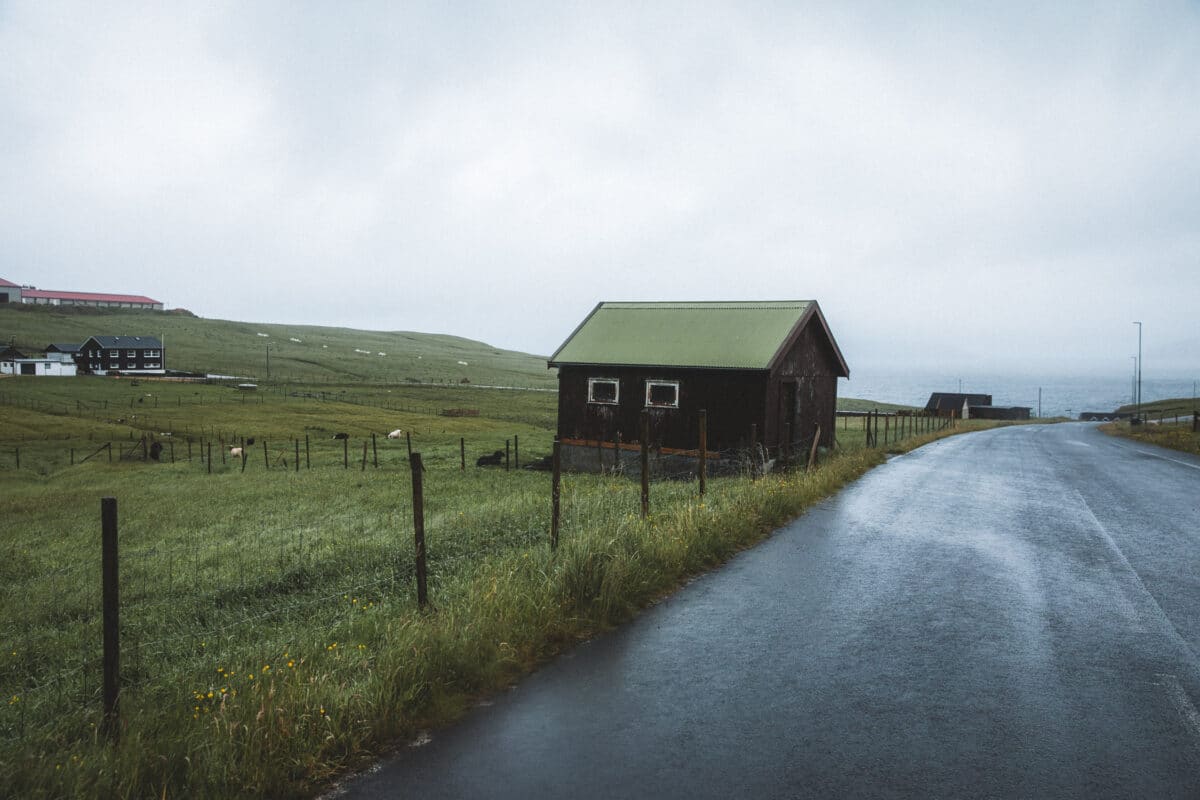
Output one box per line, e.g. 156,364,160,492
548,300,850,374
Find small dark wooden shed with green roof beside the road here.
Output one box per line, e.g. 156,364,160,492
548,300,850,468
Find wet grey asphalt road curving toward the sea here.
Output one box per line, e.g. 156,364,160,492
340,423,1200,800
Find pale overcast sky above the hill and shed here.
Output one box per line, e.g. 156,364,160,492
0,0,1200,377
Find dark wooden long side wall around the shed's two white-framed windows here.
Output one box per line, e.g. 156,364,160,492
558,365,767,450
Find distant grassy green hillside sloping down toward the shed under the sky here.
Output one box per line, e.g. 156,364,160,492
0,305,558,389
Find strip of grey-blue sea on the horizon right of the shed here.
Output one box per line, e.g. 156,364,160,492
838,371,1196,417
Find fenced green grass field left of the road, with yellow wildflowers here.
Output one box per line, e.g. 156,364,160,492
0,309,979,798
